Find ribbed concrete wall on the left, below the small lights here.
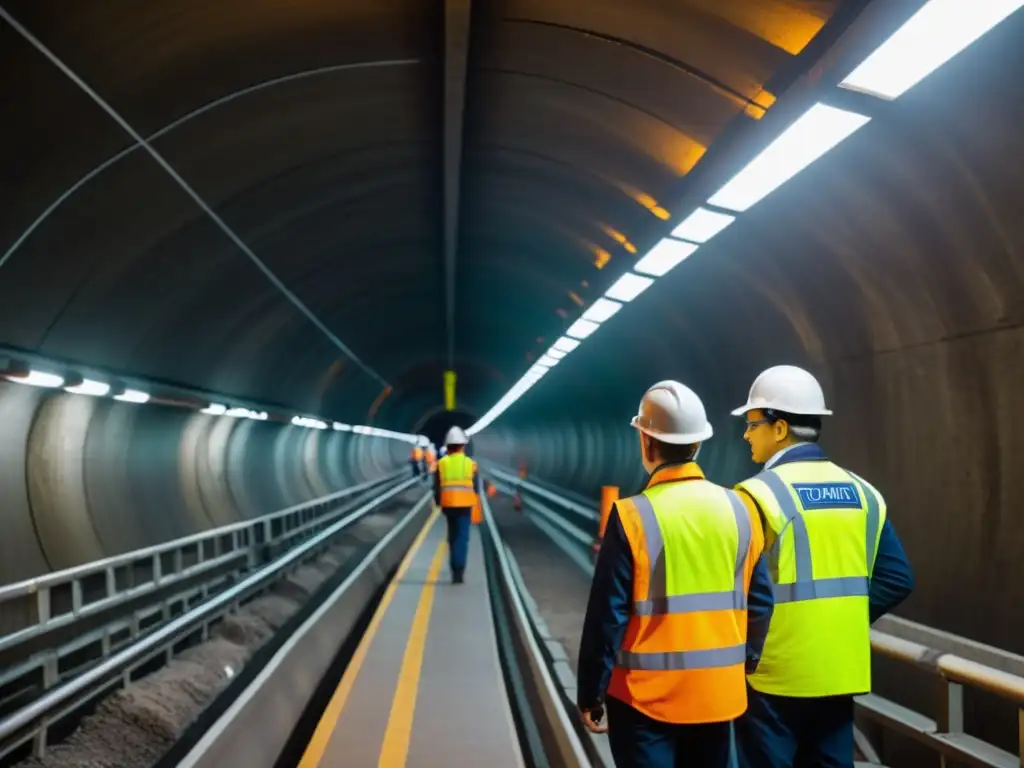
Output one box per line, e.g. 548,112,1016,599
0,383,409,584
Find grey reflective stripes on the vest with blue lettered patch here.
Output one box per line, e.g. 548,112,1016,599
757,469,880,603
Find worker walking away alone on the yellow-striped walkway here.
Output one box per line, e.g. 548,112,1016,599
434,427,480,584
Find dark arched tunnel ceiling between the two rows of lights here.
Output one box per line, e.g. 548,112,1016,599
0,0,865,427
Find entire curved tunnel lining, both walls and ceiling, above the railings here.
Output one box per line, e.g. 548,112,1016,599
0,0,1024,765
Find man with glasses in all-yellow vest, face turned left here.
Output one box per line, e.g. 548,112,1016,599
732,366,913,768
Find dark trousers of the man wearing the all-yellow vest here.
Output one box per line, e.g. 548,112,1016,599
736,686,853,768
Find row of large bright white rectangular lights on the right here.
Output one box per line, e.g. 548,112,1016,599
466,0,1024,435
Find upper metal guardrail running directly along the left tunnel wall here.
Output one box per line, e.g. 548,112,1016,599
0,472,402,714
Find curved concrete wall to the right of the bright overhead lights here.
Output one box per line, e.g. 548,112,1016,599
476,19,1024,667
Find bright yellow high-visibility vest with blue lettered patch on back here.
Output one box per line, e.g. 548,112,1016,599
737,461,886,697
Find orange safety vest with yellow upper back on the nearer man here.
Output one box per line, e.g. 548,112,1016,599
608,462,764,724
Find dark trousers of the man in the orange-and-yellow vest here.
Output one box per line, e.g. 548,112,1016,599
605,696,732,768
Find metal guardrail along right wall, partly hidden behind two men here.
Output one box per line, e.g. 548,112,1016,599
489,468,1024,768
